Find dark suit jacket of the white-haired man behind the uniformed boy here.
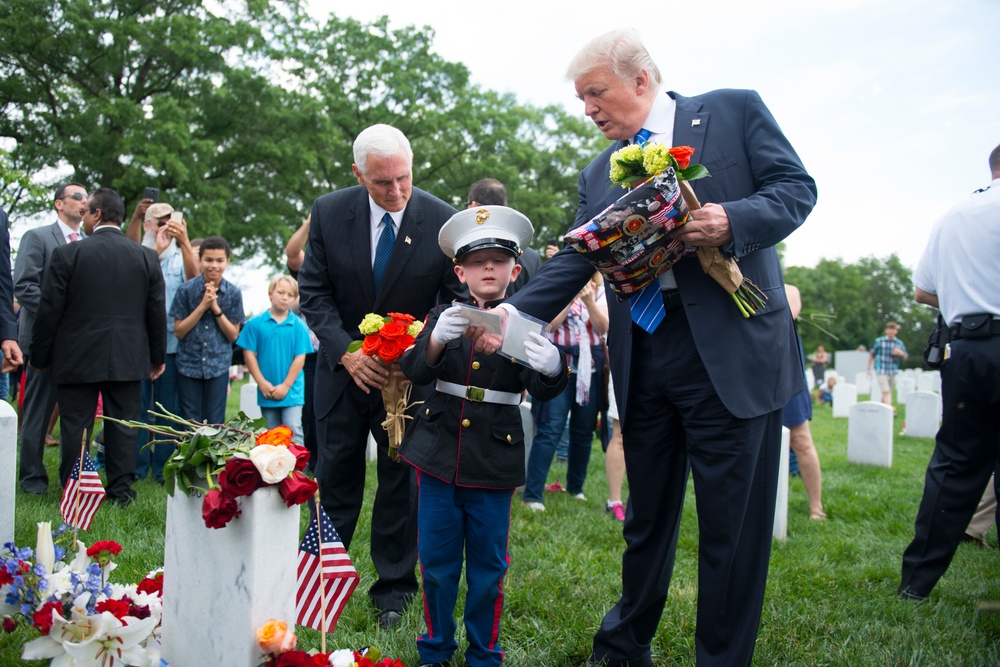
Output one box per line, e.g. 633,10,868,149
299,185,467,418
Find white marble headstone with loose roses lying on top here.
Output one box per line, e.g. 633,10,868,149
162,485,299,667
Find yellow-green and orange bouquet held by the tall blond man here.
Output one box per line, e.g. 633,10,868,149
610,143,767,317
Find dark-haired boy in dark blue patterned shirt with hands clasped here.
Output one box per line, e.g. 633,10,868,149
169,236,246,424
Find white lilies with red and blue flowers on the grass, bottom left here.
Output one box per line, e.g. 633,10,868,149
0,522,163,667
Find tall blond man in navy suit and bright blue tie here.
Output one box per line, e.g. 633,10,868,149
500,31,816,667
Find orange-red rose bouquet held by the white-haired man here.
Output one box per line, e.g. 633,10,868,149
347,313,424,461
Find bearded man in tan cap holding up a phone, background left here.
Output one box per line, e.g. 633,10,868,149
126,198,198,482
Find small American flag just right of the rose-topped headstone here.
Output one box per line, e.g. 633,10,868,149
295,506,359,632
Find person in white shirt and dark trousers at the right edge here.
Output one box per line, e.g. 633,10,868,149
899,141,1000,600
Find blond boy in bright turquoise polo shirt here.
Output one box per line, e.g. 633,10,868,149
236,276,313,445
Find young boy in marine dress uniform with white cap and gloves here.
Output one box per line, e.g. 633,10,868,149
400,206,567,667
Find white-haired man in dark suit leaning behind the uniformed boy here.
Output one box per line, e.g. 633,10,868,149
299,125,466,628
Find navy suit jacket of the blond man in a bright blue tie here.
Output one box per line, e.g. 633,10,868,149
509,90,816,422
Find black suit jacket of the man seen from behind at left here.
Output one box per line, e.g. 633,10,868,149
31,227,167,384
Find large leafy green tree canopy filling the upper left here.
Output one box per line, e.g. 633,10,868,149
0,0,603,262
